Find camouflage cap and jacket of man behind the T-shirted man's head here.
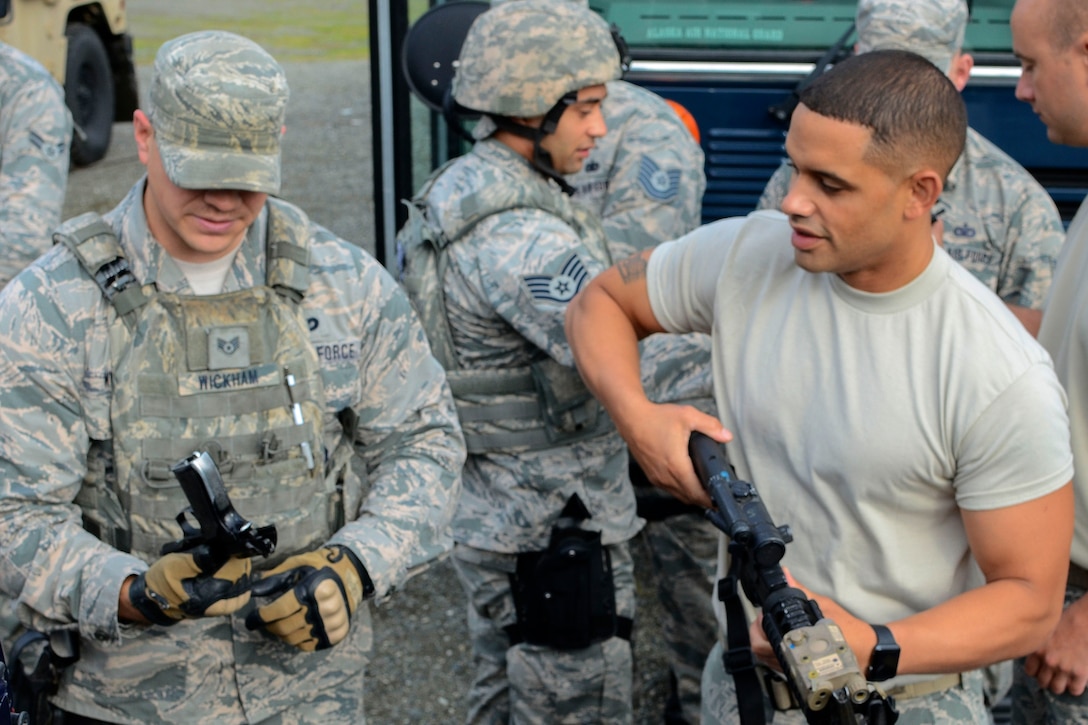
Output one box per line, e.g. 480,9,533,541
756,0,1065,309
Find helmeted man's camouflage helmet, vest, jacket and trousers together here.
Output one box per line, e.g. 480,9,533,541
409,0,642,724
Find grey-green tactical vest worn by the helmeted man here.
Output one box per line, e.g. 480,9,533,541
397,160,611,454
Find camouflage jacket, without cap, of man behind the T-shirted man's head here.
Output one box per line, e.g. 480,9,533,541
758,128,1065,309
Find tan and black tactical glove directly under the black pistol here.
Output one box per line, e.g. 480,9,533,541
128,545,250,626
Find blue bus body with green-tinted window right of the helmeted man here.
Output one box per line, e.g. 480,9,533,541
590,0,1088,223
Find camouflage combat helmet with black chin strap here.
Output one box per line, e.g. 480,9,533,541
453,0,620,118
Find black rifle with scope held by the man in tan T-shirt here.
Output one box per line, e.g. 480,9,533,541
688,432,899,725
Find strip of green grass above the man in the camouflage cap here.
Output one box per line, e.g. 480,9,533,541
128,0,429,65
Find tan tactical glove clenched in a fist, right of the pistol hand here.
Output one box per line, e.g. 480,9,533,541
246,544,374,652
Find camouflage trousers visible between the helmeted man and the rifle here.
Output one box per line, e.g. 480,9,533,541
636,488,719,725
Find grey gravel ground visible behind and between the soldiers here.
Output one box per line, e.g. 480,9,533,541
59,11,666,725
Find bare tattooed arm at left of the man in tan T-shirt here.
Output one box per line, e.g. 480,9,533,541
566,250,730,505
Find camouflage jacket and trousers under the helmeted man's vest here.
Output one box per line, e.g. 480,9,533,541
429,139,641,722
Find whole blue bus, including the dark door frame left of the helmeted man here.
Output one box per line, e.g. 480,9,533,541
370,0,1088,261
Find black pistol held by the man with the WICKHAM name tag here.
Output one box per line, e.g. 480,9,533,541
162,452,276,560
